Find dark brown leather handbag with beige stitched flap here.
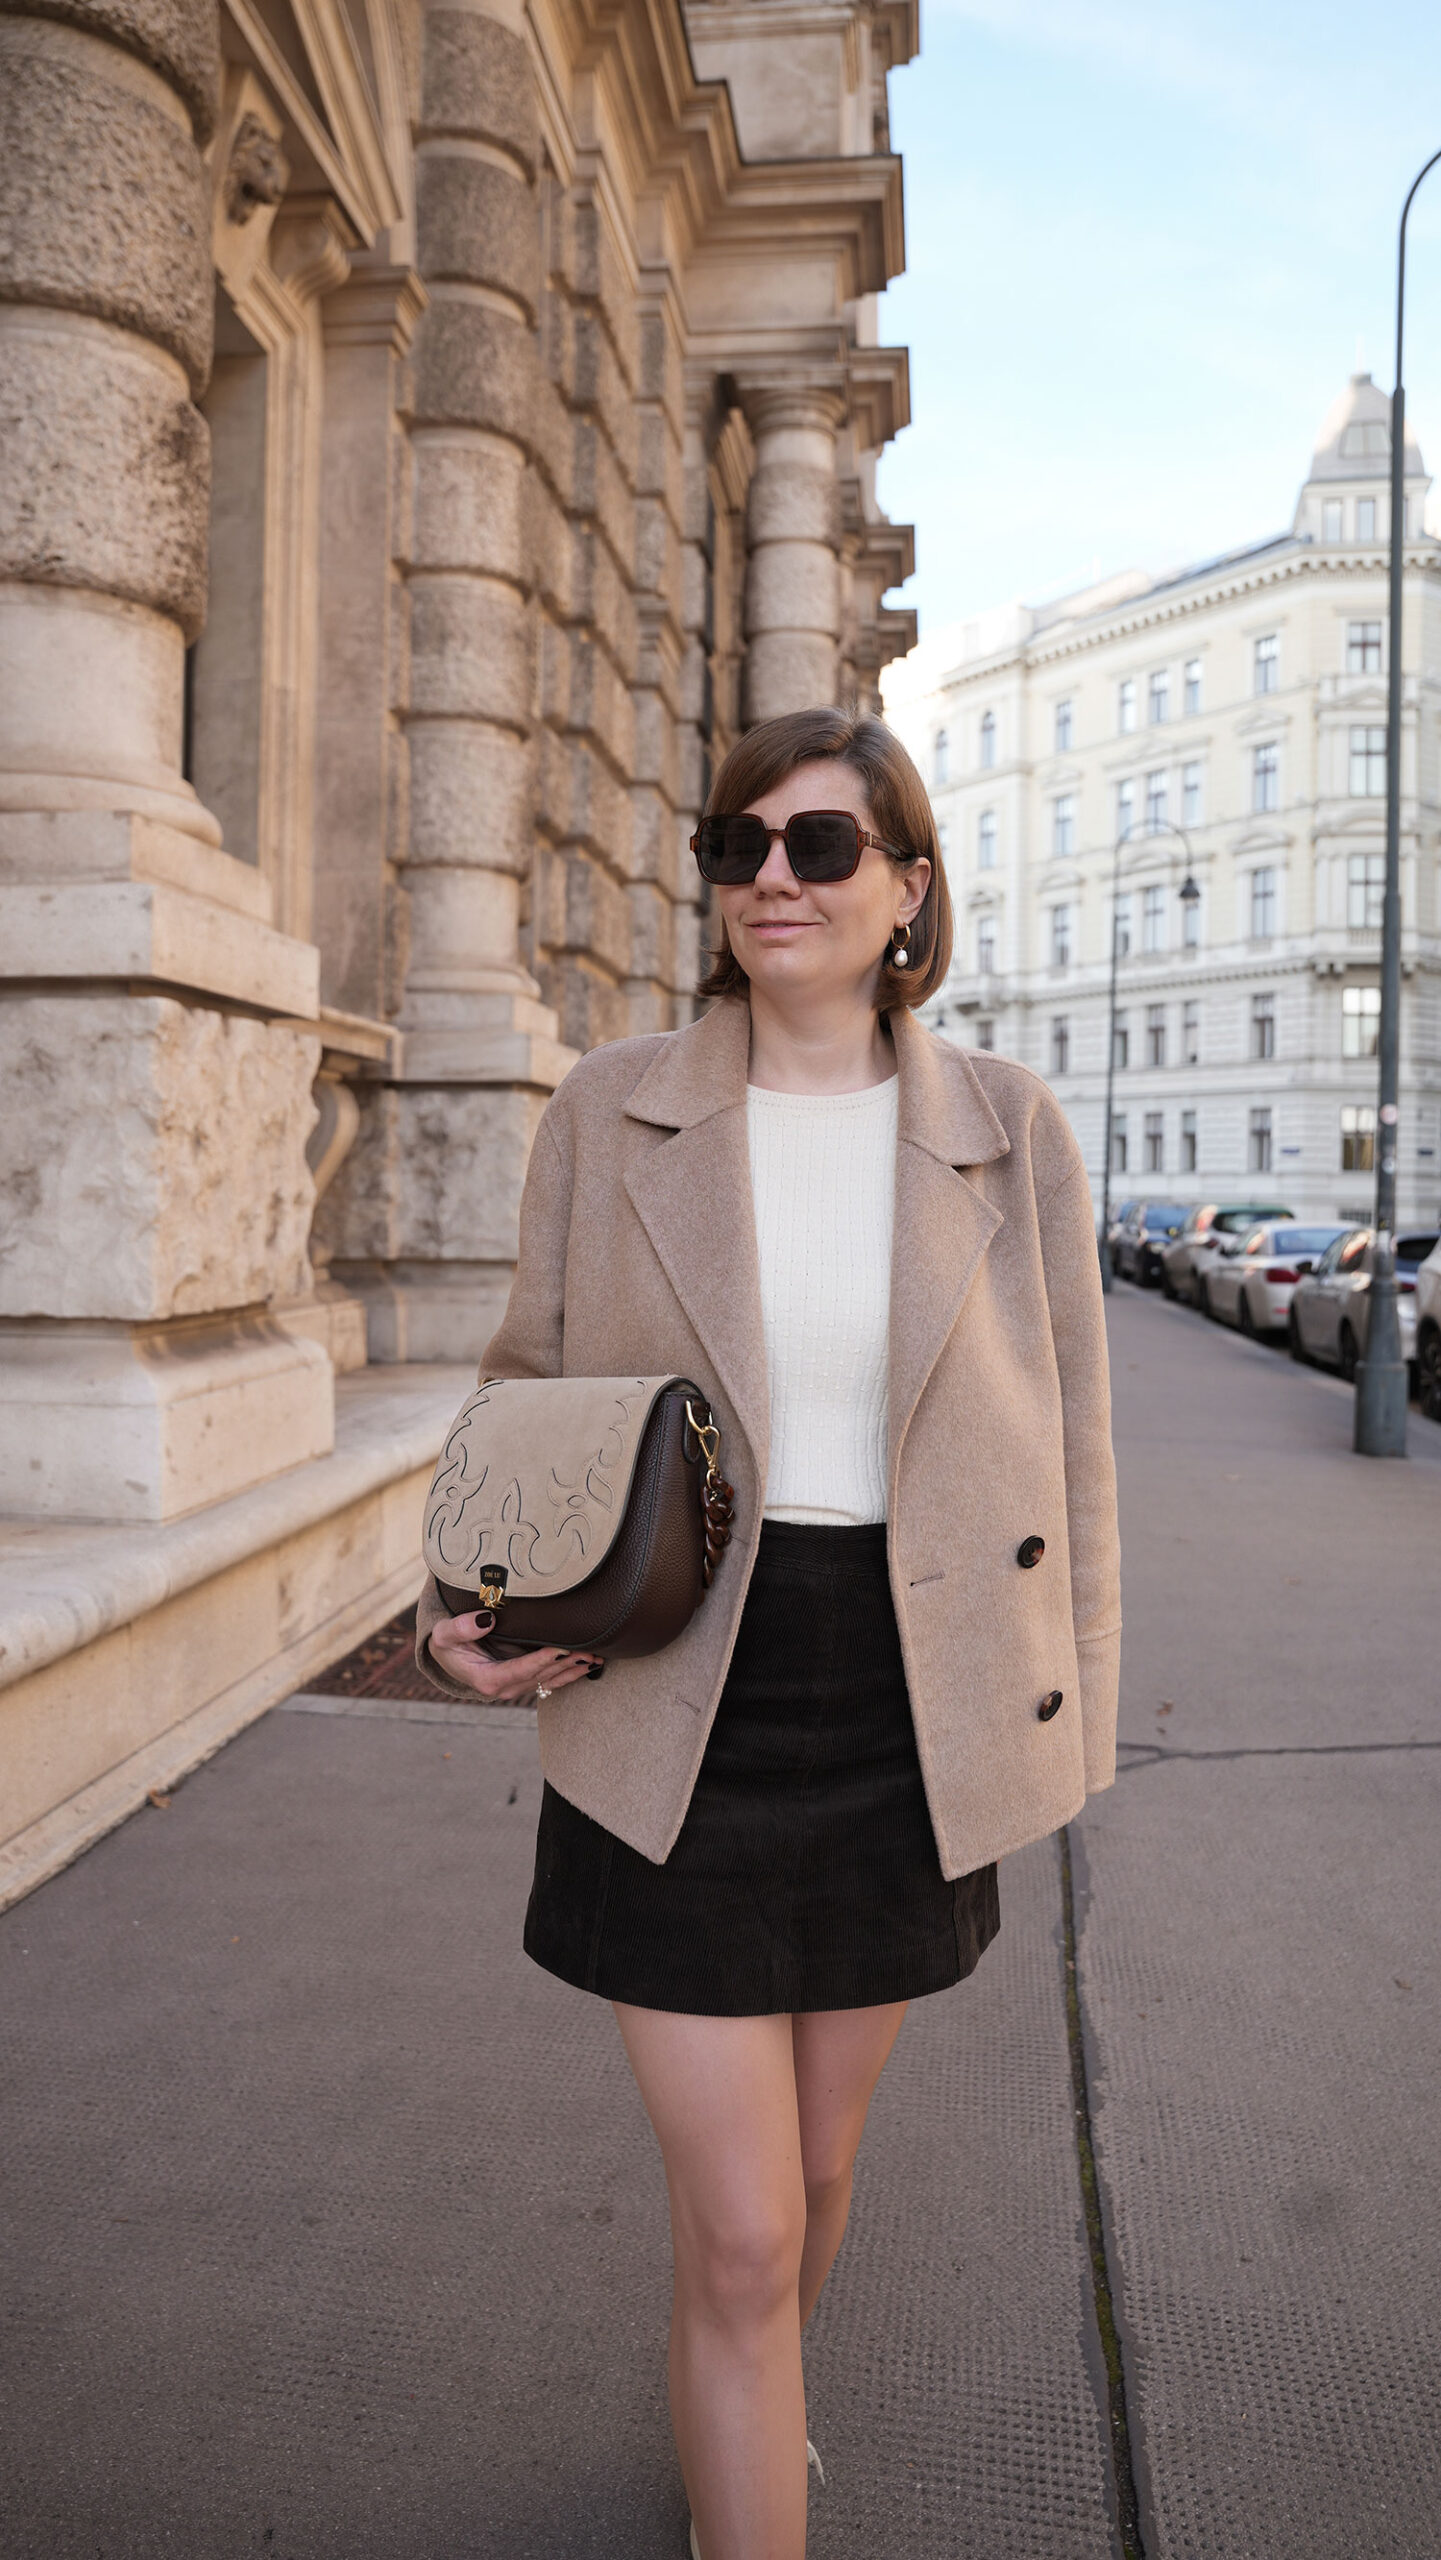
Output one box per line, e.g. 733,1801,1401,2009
422,1377,735,1659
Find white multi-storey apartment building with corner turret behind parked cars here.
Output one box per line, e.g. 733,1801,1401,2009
883,374,1441,1226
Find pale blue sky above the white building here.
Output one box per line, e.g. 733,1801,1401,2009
880,0,1441,632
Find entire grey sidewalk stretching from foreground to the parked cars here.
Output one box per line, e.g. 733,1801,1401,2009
0,1293,1441,2560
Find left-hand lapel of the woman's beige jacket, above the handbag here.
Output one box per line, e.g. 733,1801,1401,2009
625,998,770,1482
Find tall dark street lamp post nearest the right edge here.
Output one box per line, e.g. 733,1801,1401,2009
1351,151,1441,1457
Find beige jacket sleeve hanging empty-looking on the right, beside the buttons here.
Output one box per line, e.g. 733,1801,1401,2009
1037,1152,1121,1795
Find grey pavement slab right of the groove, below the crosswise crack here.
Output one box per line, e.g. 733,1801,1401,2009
1078,1751,1441,2560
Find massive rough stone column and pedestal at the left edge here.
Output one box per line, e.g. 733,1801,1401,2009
0,0,333,1521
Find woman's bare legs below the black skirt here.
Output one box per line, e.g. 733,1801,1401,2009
614,2002,906,2560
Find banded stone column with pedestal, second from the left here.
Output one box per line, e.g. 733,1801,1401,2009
325,0,571,1359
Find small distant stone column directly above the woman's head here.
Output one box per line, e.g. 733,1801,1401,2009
742,389,845,727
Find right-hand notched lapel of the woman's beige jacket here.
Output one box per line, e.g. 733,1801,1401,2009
888,1011,1011,1495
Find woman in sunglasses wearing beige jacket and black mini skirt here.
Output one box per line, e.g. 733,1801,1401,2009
417,709,1119,2560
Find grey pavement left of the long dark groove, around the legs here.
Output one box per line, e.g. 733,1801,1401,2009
0,1713,1108,2560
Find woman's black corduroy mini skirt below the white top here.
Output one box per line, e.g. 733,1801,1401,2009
525,1521,1001,2017
